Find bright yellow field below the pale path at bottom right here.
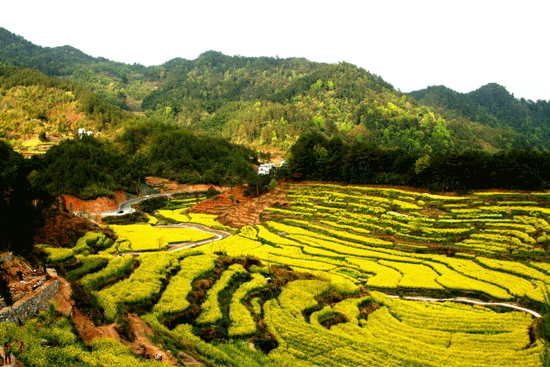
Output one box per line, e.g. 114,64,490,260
264,284,542,366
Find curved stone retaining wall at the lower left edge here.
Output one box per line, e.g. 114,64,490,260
0,269,59,325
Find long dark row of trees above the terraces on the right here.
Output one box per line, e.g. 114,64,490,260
279,133,550,192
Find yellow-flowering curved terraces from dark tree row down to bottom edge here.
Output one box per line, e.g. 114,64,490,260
64,185,550,366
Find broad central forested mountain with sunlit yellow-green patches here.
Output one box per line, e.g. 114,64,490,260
142,51,528,153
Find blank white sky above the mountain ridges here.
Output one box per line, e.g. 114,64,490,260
0,0,550,101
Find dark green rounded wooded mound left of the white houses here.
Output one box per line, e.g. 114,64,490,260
25,121,264,199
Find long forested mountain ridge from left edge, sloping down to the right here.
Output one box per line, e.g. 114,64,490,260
0,28,546,154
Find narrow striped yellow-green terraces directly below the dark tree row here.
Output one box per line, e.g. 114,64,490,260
270,184,550,260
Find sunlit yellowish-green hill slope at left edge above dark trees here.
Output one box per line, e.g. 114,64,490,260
0,65,132,145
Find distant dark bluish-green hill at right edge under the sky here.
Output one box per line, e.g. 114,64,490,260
409,83,550,150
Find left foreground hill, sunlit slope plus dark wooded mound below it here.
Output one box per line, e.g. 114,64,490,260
0,40,264,199
